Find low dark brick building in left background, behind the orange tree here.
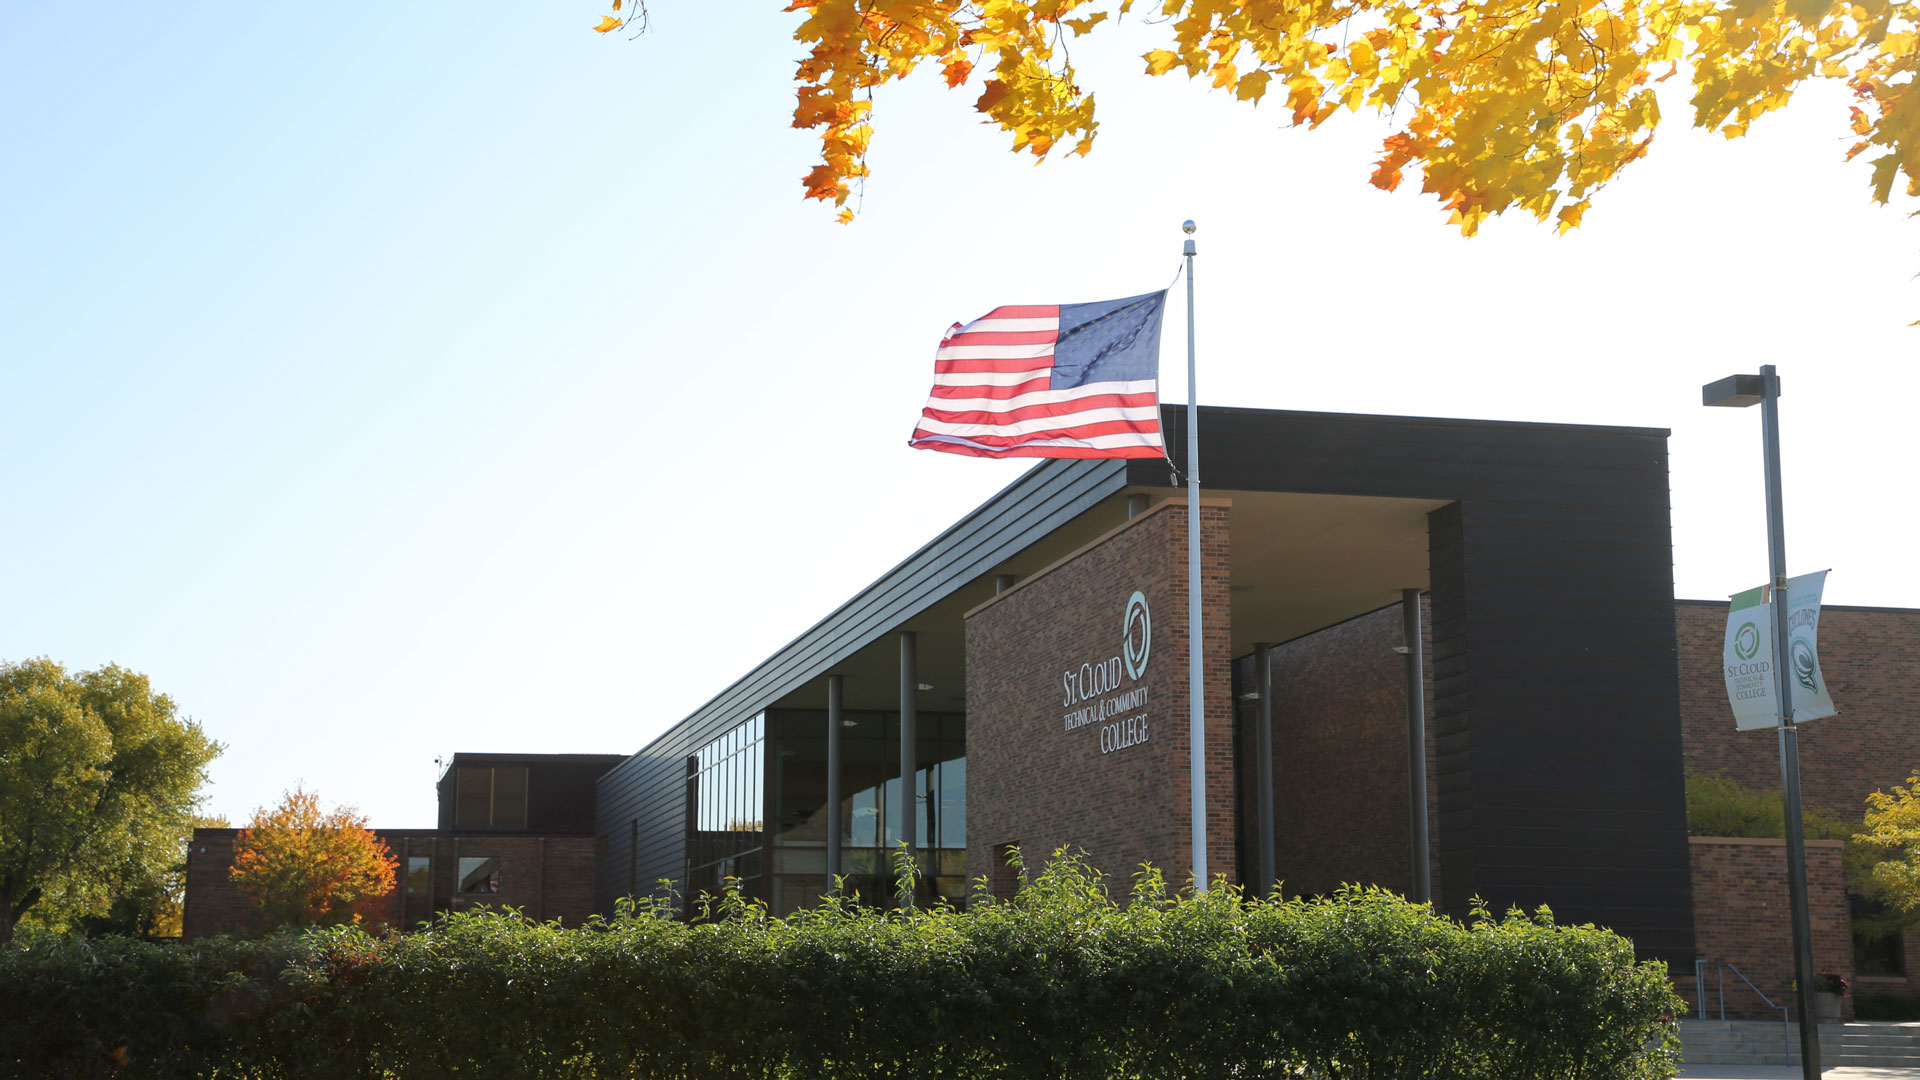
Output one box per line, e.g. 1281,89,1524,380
182,753,622,938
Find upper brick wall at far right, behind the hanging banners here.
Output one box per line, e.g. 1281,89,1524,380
1674,601,1920,821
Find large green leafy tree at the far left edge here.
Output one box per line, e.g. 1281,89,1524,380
0,657,225,942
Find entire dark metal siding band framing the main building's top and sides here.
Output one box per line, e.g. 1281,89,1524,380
595,409,1693,963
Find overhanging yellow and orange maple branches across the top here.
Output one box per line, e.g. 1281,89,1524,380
595,0,1920,244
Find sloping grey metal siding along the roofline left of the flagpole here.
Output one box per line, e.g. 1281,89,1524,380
595,453,1128,911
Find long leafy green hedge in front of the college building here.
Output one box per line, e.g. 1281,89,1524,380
0,855,1684,1080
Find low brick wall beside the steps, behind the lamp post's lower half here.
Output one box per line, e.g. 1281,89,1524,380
1674,834,1853,1020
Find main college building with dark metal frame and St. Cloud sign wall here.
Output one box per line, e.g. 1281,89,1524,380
597,399,1695,970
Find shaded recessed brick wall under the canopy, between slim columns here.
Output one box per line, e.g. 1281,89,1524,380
1273,598,1440,896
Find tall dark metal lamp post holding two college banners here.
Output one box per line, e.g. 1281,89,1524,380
1693,363,1820,1080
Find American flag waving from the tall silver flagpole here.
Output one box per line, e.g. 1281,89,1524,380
908,292,1167,457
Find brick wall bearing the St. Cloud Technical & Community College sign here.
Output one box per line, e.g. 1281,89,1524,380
966,500,1235,897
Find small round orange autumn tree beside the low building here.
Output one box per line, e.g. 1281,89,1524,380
232,788,399,926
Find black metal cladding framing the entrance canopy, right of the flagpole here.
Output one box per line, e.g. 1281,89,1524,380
1131,409,1693,965
